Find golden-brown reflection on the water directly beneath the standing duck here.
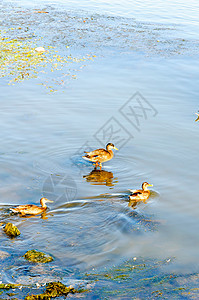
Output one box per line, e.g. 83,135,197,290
83,168,116,186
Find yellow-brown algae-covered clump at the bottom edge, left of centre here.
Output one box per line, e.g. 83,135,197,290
25,281,82,300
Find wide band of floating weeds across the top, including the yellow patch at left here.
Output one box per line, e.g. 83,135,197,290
0,6,199,92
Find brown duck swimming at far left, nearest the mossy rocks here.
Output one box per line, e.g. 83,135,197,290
11,197,53,216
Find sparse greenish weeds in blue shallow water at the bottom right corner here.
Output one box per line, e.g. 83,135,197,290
83,258,199,299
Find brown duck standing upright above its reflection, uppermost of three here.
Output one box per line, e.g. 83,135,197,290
82,143,118,171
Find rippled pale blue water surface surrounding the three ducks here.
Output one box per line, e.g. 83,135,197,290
0,0,199,292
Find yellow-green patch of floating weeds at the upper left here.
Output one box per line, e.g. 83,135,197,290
0,27,95,92
